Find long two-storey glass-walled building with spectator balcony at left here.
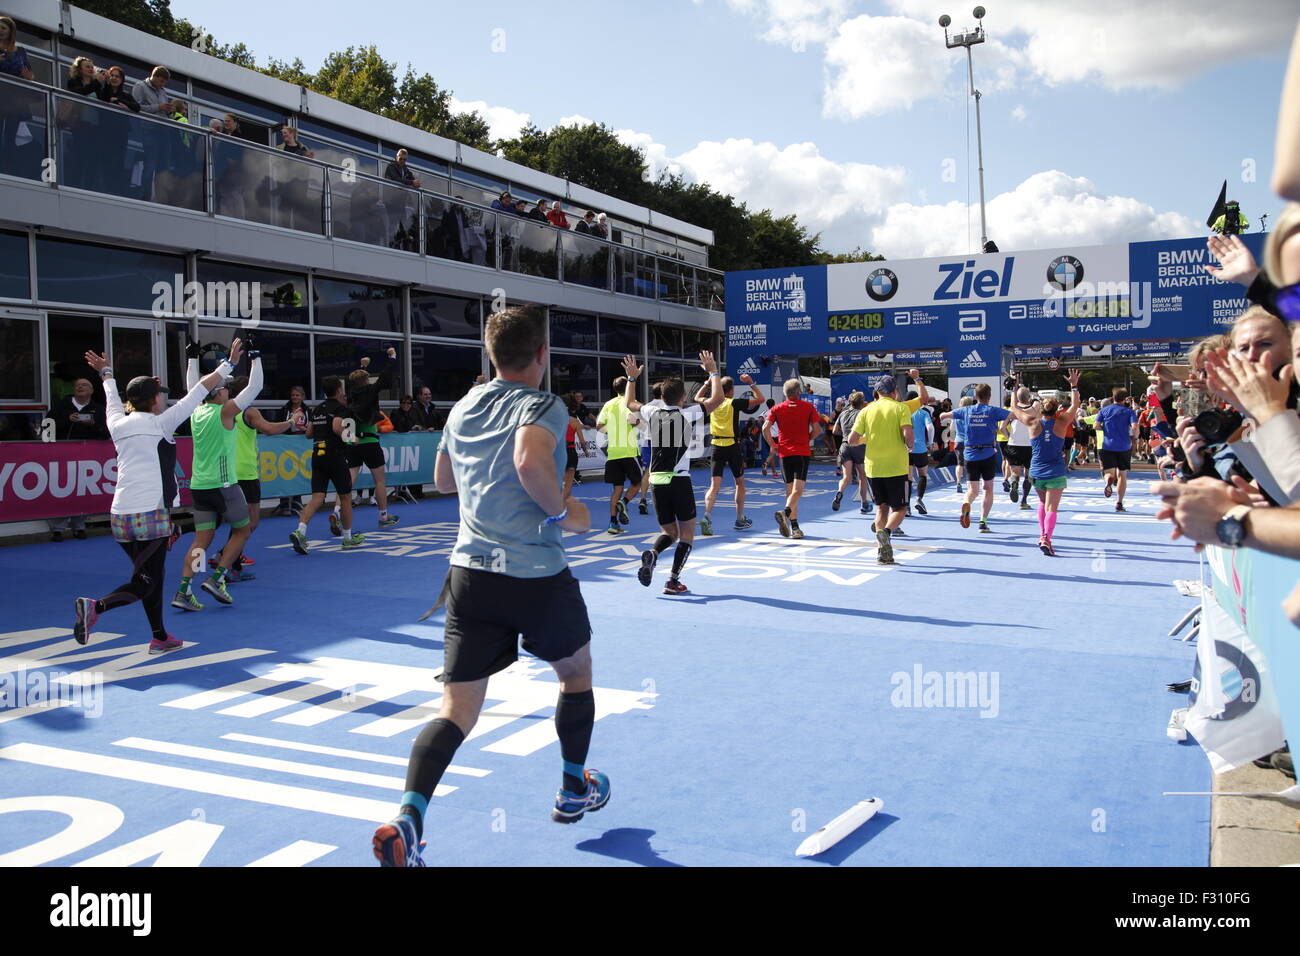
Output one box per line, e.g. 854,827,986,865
0,0,724,426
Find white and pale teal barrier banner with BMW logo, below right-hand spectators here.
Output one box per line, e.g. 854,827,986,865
1187,546,1300,773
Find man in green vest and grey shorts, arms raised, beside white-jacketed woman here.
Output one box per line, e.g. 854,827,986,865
172,333,263,611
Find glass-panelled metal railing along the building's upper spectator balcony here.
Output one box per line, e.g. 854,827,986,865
0,77,724,311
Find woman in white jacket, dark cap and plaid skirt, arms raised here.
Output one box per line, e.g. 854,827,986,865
73,338,243,654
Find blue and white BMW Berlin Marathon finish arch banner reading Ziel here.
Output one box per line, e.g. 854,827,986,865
727,233,1265,399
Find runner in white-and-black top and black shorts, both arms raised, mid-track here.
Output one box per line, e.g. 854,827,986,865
623,351,723,594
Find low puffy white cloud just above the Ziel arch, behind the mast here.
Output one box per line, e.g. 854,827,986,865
867,169,1204,259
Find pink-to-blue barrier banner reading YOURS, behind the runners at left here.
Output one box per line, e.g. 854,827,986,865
0,432,442,522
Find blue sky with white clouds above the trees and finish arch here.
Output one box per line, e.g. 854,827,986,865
173,0,1297,256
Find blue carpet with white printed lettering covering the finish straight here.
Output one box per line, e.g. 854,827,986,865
0,466,1210,866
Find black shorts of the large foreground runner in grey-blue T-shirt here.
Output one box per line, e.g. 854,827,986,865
439,567,592,683
